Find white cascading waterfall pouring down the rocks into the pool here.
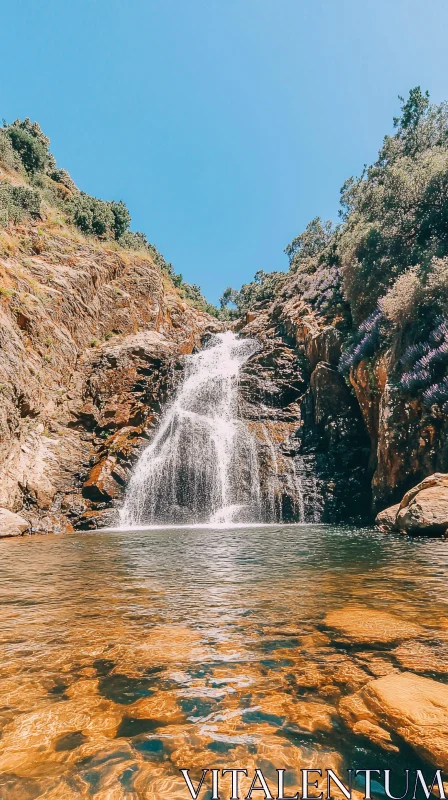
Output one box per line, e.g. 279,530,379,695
120,331,261,526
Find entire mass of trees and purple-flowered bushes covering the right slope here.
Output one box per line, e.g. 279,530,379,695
285,87,448,413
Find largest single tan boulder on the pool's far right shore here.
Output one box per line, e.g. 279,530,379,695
397,484,448,535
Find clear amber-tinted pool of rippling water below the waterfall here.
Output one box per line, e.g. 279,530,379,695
0,526,448,800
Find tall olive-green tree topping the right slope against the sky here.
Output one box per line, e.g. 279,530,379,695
338,87,448,322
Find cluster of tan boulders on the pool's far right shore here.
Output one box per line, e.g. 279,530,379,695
376,473,448,536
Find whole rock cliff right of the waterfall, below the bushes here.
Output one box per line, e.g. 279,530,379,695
237,275,448,522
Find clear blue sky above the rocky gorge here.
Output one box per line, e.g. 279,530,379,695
0,0,448,302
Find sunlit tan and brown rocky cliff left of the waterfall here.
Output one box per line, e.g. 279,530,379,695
0,219,221,532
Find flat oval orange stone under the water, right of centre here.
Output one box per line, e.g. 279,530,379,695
324,606,423,644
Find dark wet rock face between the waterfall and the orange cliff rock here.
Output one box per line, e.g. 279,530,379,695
241,304,371,522
